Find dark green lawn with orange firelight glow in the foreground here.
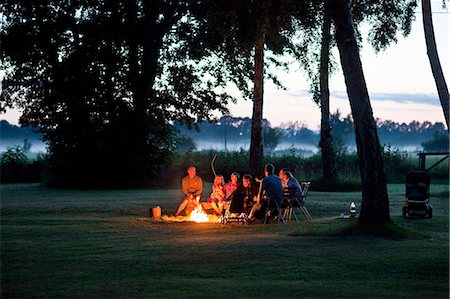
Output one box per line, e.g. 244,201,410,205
1,184,449,298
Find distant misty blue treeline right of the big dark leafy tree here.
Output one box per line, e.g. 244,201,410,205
175,111,448,151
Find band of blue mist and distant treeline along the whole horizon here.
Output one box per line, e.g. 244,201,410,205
0,112,445,157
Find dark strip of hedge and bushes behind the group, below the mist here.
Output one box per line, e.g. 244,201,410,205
1,145,449,191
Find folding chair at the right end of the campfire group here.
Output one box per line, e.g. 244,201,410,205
283,182,312,223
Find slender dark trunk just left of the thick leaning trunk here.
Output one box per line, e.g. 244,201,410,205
319,9,336,191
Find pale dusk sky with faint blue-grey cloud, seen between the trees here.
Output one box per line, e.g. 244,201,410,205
0,0,450,130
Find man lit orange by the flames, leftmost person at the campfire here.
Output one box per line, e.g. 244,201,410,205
175,166,203,216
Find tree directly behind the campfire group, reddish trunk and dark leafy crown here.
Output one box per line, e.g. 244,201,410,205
186,0,319,176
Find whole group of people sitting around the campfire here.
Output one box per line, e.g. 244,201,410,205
175,164,302,222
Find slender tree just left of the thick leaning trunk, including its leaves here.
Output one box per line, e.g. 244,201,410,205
296,0,416,189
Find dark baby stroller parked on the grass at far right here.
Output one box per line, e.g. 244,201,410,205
402,171,433,218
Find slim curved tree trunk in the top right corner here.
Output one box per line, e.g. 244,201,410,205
422,0,449,130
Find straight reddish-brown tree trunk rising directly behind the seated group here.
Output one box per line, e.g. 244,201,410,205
250,31,264,177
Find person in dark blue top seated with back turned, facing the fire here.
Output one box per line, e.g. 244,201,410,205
249,164,283,220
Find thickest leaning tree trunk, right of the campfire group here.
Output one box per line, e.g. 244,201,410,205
326,0,390,228
